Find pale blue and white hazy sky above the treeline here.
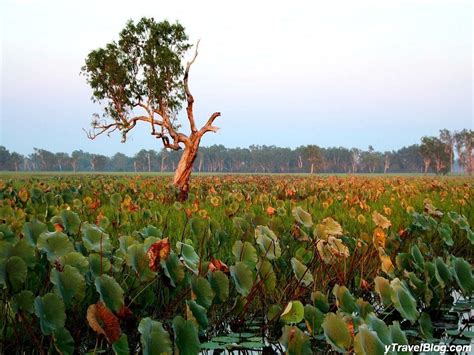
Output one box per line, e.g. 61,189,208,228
0,0,473,154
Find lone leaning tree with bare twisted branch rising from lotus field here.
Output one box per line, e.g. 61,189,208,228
82,18,221,199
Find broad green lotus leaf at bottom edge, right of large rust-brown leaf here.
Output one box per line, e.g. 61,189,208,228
138,317,173,355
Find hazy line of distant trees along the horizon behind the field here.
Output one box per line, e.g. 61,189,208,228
0,129,474,174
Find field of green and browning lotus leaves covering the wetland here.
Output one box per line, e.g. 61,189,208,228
0,175,474,354
